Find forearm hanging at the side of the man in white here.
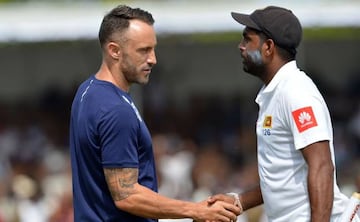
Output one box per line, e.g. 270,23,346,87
308,161,334,222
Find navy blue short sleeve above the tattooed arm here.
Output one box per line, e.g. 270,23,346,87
99,105,139,168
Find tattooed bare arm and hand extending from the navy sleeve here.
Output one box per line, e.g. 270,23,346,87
104,168,240,221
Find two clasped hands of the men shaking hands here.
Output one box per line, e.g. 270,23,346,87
193,193,243,222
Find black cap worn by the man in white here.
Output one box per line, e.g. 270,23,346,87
231,6,302,53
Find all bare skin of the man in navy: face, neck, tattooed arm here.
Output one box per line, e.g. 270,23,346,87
96,20,240,222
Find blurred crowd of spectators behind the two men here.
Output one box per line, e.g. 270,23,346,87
0,72,360,222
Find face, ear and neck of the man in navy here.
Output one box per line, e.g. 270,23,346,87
96,20,157,92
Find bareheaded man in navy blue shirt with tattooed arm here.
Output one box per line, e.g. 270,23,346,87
70,6,240,222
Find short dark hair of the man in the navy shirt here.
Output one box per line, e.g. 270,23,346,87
99,5,155,47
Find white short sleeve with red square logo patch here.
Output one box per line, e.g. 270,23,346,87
284,93,332,149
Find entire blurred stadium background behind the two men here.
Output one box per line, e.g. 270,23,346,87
0,0,360,222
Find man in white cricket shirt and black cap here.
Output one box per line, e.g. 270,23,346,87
209,6,358,222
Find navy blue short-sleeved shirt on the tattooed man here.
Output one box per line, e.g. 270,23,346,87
70,76,157,222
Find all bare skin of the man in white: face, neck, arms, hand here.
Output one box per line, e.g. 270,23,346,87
208,27,334,222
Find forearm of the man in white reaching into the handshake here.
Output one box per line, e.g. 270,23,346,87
239,184,263,211
